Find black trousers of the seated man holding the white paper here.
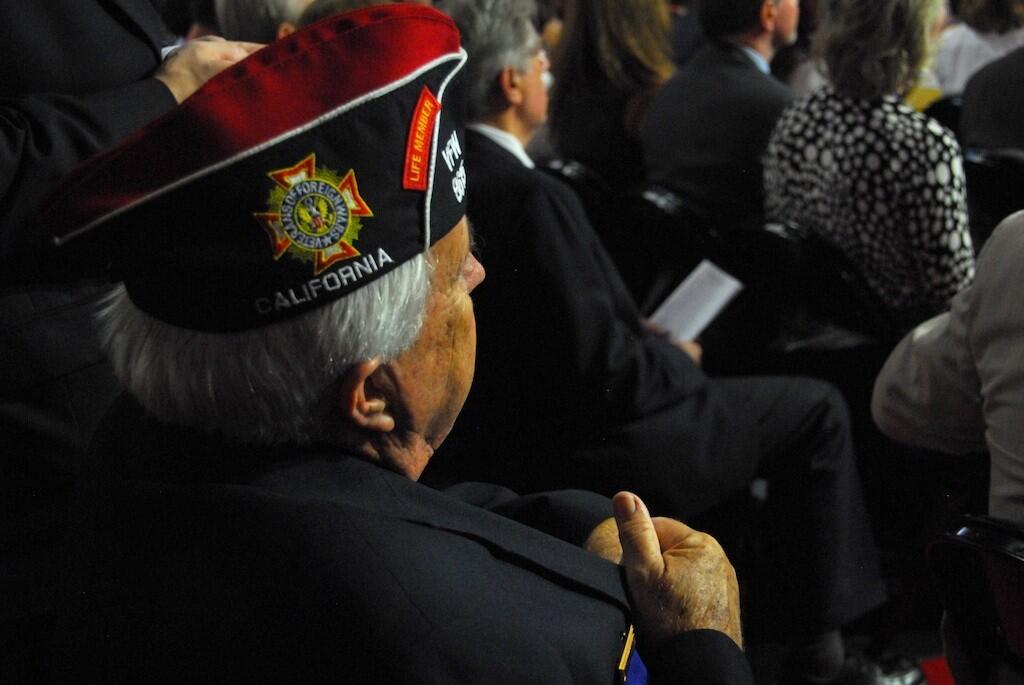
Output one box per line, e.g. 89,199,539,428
564,377,886,634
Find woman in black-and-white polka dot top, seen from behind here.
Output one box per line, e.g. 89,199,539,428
765,0,974,329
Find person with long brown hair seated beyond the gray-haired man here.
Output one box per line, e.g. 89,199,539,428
548,0,675,192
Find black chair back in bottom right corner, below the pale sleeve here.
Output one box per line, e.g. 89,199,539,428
928,516,1024,683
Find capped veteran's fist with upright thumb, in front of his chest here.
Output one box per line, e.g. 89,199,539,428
612,493,742,649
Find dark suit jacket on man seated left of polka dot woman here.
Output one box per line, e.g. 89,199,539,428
640,40,793,226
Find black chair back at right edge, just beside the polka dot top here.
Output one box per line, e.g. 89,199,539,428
964,148,1024,253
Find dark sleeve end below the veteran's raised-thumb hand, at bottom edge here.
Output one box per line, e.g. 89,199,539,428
640,630,754,685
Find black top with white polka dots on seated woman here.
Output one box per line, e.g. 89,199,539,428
764,87,974,319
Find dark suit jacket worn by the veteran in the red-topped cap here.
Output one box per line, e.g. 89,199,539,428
58,399,752,685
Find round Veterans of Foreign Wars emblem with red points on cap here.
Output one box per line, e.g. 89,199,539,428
253,154,374,275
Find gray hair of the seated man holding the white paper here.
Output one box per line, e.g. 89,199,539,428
435,0,541,121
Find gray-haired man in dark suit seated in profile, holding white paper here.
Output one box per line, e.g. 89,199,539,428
436,0,901,683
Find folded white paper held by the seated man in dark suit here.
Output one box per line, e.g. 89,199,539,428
650,259,743,340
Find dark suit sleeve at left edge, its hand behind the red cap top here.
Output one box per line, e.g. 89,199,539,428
0,79,175,283
